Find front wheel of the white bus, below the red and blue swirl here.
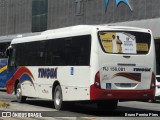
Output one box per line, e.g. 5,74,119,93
16,83,27,103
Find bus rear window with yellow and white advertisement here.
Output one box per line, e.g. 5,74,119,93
98,31,151,54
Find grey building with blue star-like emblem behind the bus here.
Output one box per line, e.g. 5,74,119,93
0,0,160,74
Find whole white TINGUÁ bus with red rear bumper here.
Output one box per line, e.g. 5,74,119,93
7,25,156,110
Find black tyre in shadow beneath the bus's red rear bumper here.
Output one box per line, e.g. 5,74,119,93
97,100,118,111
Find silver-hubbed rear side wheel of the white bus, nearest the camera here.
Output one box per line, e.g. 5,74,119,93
54,85,63,110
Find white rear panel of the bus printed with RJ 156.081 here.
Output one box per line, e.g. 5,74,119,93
99,30,156,90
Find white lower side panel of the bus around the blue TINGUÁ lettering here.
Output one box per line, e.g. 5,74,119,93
21,66,90,101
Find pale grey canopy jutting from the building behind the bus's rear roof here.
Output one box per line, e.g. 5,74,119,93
111,18,160,39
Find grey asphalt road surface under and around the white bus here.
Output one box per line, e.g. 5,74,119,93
0,90,160,120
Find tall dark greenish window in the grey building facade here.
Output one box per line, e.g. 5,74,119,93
32,0,48,32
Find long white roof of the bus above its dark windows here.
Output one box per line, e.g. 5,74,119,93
12,25,150,44
